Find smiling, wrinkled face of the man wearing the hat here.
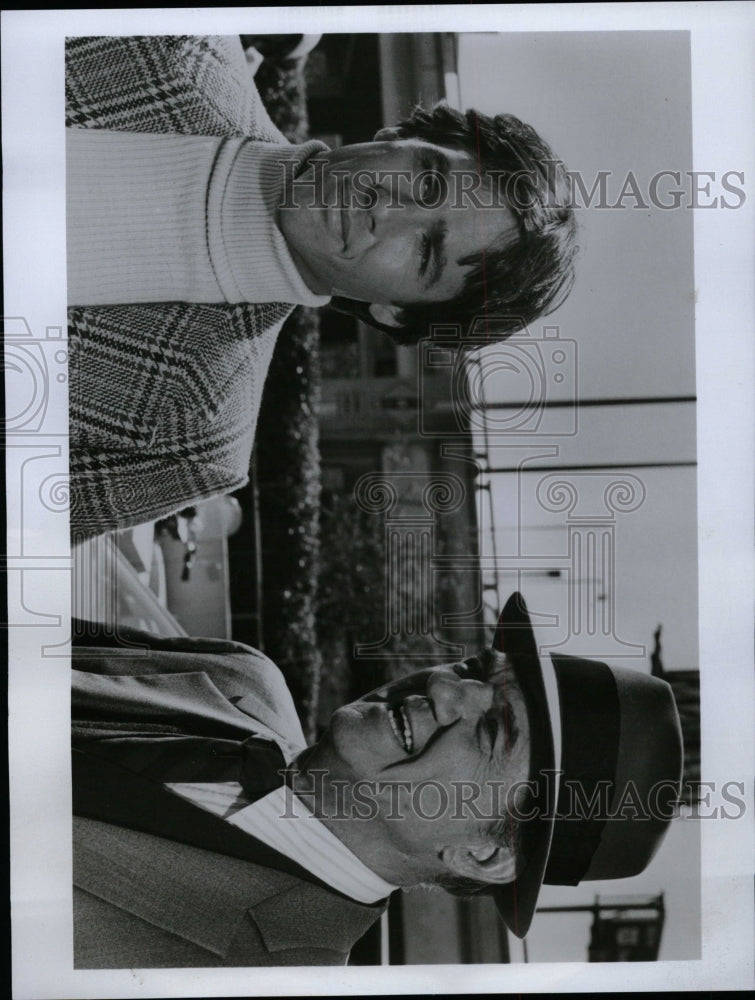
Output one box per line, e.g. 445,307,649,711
300,650,530,881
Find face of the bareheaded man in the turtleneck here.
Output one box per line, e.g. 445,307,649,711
280,130,517,306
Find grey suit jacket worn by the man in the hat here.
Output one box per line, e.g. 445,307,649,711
73,633,385,968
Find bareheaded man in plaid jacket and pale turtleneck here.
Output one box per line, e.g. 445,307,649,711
66,37,576,536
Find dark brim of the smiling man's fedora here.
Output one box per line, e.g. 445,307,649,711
490,592,561,938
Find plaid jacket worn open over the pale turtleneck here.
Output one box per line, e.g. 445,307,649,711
66,36,292,539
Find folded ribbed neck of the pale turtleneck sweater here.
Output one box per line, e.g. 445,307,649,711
206,138,330,306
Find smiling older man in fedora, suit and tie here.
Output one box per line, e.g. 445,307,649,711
73,594,682,968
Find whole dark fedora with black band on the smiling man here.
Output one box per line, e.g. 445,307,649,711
489,593,682,937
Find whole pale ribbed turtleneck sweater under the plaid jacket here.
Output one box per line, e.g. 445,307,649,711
66,129,329,306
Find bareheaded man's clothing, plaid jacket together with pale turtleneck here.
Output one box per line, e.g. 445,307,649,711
65,35,336,539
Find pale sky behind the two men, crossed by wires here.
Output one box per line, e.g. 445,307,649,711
459,32,700,961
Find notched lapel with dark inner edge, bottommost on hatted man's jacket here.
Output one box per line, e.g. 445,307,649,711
72,749,383,955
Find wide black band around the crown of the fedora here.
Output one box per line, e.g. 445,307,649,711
544,653,620,885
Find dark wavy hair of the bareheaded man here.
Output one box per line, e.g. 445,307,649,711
331,103,578,346
